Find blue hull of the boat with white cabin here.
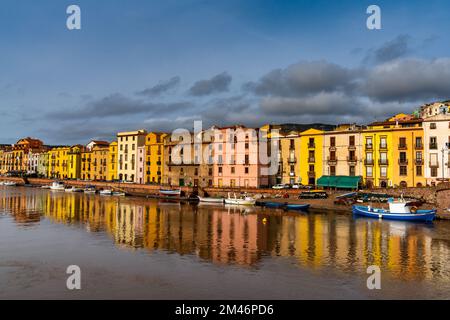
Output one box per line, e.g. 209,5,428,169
352,206,436,222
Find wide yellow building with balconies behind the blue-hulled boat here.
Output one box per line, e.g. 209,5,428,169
362,114,426,188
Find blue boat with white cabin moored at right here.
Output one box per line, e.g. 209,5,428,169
353,199,436,222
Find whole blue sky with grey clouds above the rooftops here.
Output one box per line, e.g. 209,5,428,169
0,0,450,144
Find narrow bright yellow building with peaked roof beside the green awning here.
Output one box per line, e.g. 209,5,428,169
299,129,324,185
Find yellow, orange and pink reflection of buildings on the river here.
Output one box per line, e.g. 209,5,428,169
0,187,450,280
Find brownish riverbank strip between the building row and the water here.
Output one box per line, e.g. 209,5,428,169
0,177,450,220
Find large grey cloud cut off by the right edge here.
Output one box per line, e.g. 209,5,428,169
361,58,450,102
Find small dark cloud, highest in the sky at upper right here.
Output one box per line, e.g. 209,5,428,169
363,34,413,64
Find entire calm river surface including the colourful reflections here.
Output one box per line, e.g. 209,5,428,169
0,186,450,299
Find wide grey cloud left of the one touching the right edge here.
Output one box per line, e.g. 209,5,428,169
243,61,358,97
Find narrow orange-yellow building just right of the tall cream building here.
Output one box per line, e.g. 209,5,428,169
144,132,167,184
